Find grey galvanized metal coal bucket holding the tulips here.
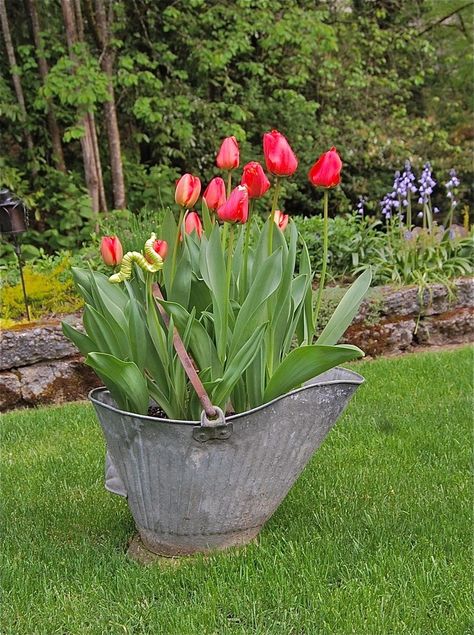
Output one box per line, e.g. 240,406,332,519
89,368,364,556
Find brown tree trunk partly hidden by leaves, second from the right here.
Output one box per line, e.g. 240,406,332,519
61,0,107,213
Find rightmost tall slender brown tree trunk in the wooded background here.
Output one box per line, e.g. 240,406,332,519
95,0,126,209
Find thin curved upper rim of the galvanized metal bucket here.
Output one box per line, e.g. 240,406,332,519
88,366,365,426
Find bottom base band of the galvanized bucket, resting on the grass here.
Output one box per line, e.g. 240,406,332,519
138,525,262,558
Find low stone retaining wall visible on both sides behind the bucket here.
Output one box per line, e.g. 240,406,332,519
0,278,474,410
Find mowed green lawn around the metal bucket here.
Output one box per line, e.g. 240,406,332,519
1,349,472,635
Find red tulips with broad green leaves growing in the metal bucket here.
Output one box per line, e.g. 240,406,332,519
63,131,371,419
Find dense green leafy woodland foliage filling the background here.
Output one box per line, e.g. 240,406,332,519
0,0,474,250
